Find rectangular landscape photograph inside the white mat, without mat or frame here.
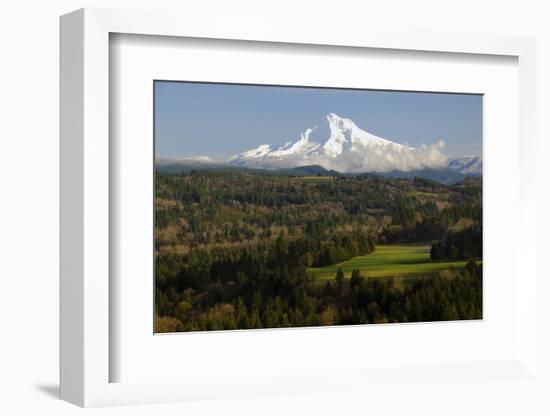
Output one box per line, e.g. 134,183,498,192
154,81,483,332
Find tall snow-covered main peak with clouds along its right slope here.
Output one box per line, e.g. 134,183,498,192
228,113,449,173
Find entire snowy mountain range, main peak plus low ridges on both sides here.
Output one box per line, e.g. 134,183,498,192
156,113,482,183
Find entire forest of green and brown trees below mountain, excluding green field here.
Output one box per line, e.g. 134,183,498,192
155,169,482,332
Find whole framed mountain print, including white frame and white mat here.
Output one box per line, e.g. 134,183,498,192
61,9,538,408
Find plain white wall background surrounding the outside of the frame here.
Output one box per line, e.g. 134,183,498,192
0,0,550,415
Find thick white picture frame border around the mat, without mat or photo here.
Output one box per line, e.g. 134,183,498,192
60,9,537,407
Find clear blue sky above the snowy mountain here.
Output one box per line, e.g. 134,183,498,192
155,81,482,158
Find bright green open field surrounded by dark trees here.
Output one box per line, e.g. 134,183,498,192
307,244,474,279
